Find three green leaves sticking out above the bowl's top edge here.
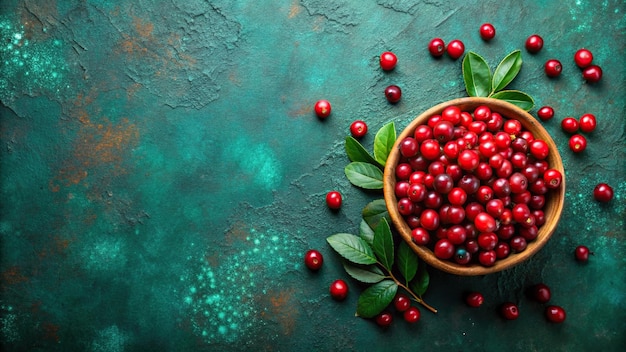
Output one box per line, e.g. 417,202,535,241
463,50,535,111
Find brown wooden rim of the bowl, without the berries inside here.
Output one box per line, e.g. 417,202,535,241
384,97,565,276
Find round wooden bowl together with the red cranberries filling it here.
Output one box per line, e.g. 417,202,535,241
384,98,565,275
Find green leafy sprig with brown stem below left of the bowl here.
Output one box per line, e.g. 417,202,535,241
326,217,437,318
